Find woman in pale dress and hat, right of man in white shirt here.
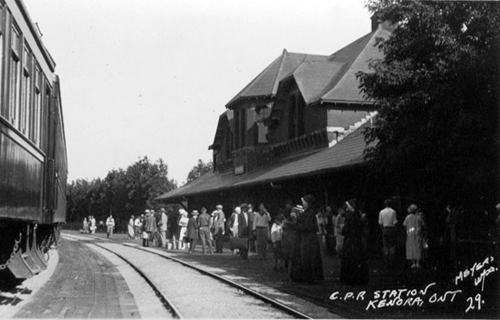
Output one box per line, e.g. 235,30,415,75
403,204,423,269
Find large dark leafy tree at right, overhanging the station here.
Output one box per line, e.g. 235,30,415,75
357,0,500,208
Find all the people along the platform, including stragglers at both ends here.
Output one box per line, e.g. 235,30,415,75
84,194,500,285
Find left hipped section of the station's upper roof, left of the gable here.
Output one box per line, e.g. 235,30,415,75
226,50,328,108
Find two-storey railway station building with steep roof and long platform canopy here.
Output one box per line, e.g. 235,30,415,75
157,22,391,228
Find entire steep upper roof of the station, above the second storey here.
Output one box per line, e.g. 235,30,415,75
226,24,391,108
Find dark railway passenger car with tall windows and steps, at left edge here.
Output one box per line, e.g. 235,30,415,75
0,0,68,278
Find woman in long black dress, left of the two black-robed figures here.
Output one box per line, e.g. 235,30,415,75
290,194,324,283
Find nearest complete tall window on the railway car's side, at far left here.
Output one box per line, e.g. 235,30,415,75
9,25,21,129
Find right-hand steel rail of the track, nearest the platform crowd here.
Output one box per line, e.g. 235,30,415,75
121,243,313,319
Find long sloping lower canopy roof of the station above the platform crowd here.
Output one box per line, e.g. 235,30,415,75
156,122,369,201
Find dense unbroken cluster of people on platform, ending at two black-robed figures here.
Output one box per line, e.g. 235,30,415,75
110,194,368,283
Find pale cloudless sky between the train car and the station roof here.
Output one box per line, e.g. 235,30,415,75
24,0,371,186
